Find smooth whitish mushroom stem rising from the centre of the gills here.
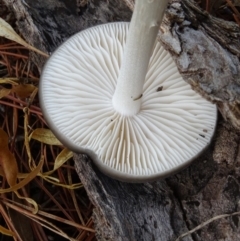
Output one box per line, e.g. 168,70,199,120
112,0,168,116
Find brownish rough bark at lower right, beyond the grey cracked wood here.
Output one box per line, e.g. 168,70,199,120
167,122,240,241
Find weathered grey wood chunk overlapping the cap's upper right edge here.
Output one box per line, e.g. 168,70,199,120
160,0,240,129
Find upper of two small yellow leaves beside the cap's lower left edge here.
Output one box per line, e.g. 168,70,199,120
29,128,62,146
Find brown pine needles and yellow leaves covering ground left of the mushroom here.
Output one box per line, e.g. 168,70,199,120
0,6,96,241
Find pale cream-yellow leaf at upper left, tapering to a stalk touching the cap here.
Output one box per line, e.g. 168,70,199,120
0,18,48,57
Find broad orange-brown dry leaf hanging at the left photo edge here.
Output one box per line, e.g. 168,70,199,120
0,128,18,187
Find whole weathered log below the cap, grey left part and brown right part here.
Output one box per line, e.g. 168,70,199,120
74,121,240,241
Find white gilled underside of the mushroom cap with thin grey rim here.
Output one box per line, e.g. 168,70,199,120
39,22,217,182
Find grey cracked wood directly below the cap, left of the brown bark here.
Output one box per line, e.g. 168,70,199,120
75,155,192,241
